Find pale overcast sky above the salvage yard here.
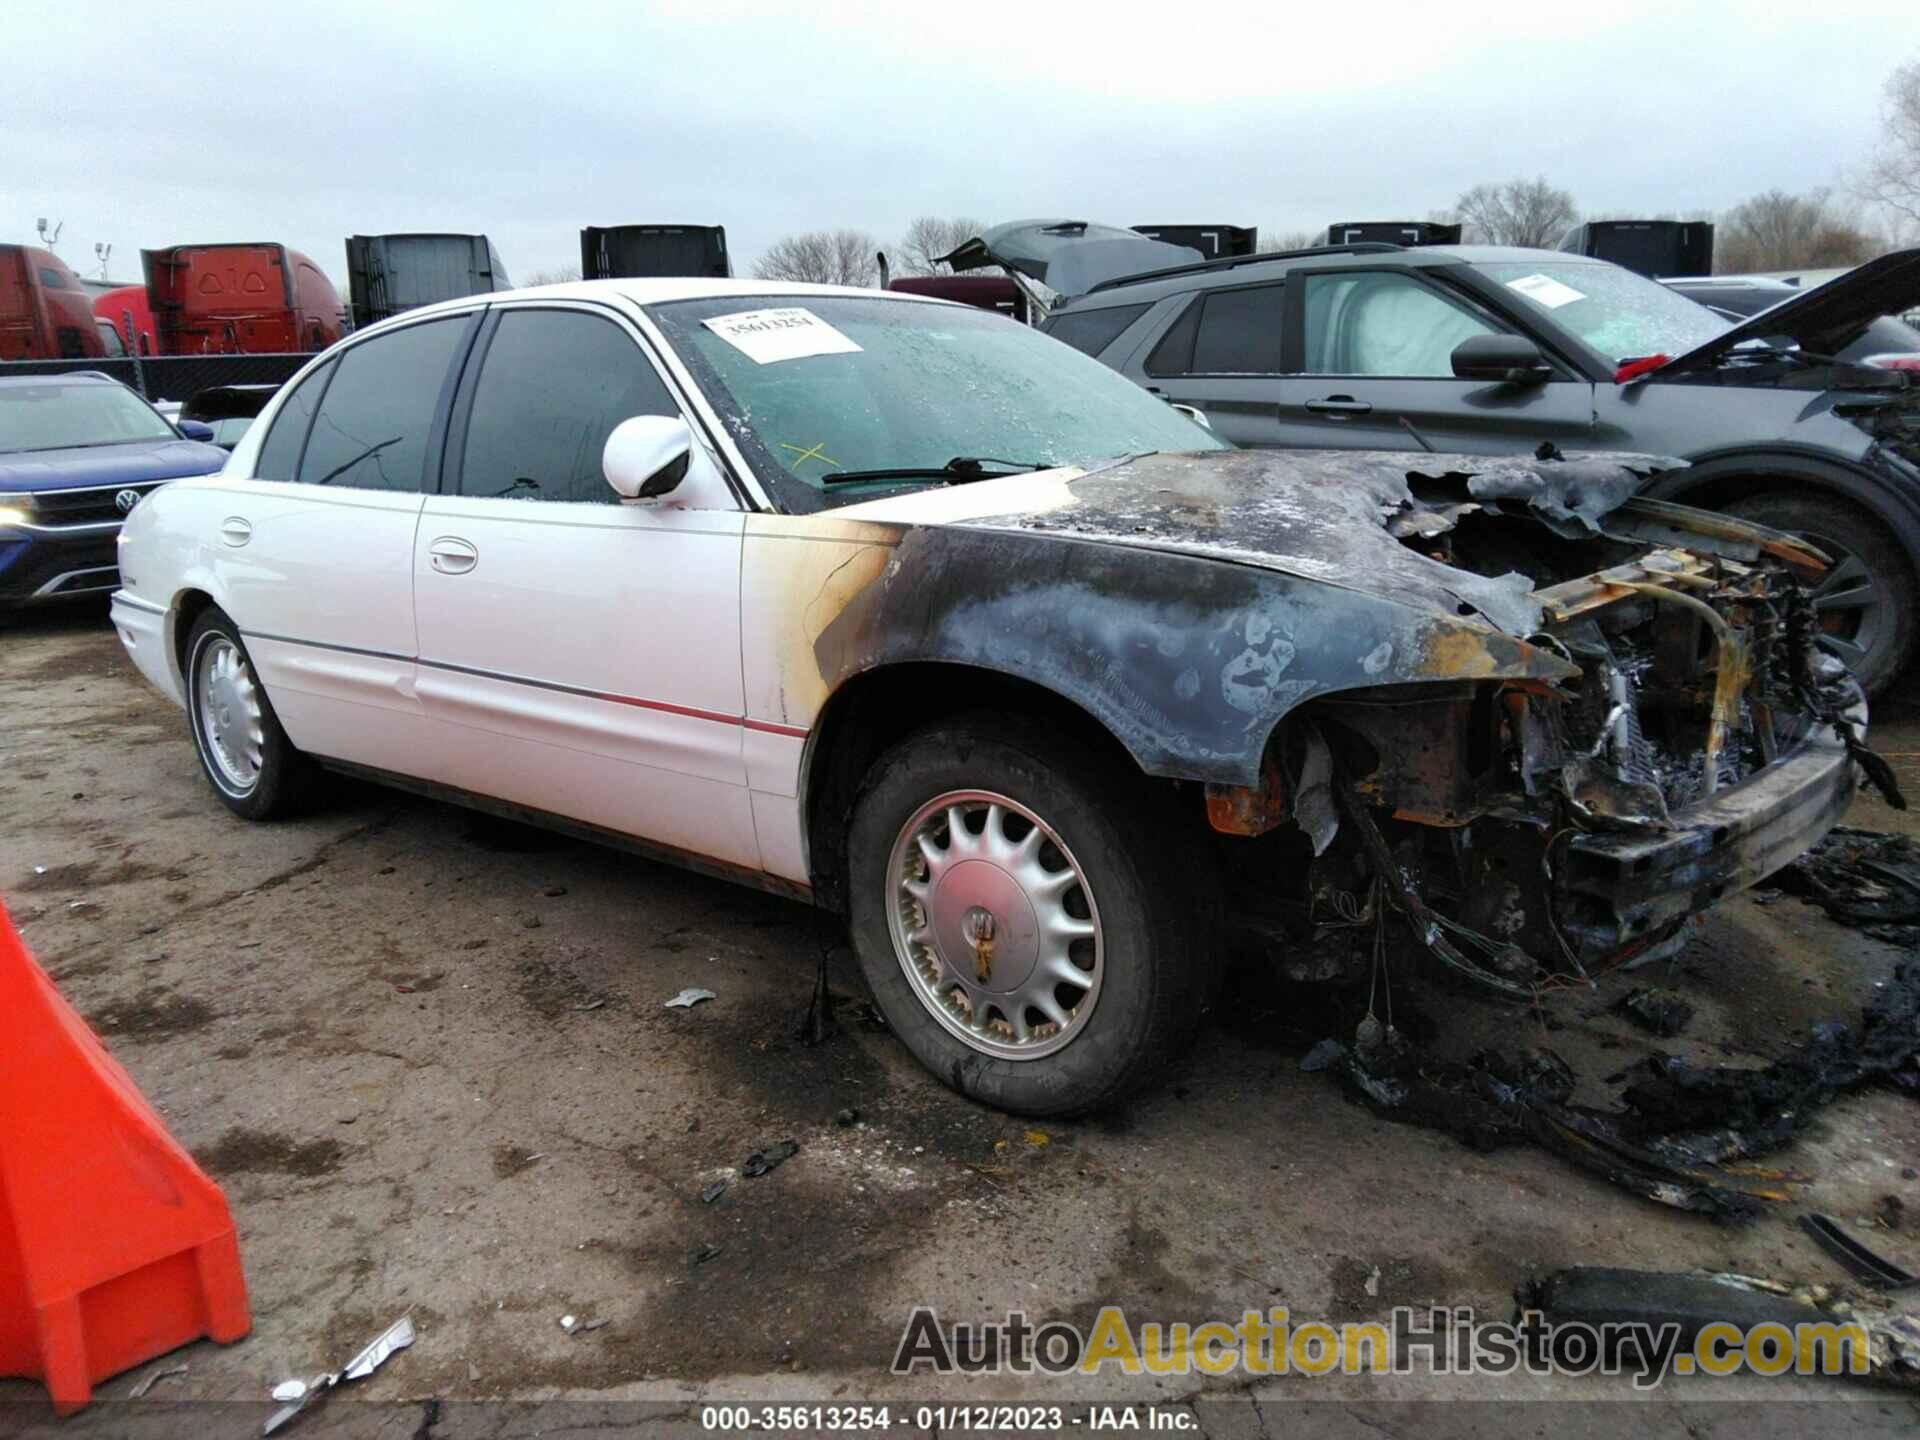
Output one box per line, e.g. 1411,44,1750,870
15,0,1920,290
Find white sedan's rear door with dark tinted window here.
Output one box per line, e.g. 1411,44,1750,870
219,311,480,772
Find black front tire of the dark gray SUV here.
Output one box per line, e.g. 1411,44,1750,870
1724,490,1920,695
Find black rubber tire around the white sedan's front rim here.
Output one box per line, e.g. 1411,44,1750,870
849,716,1213,1116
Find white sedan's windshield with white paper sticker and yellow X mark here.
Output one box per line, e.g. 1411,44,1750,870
647,294,1225,511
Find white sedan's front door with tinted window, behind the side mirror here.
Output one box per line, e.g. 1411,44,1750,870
413,301,758,870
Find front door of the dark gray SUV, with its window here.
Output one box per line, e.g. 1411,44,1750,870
1267,269,1594,455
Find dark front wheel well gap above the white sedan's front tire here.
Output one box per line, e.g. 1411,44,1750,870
801,660,1144,910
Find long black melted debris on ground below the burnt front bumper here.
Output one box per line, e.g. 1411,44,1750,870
1302,962,1920,1219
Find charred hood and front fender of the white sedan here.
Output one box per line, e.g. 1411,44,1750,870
814,451,1820,785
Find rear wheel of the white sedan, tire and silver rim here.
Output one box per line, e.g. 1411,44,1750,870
184,609,313,820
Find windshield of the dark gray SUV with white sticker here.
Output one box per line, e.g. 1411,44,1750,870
1476,259,1730,363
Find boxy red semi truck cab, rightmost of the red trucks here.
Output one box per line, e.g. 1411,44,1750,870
140,244,340,355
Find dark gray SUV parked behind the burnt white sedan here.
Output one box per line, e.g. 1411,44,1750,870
981,232,1920,687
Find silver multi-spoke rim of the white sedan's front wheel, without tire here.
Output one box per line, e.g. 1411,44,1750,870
887,791,1104,1060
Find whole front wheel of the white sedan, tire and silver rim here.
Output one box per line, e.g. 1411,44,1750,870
849,718,1208,1116
